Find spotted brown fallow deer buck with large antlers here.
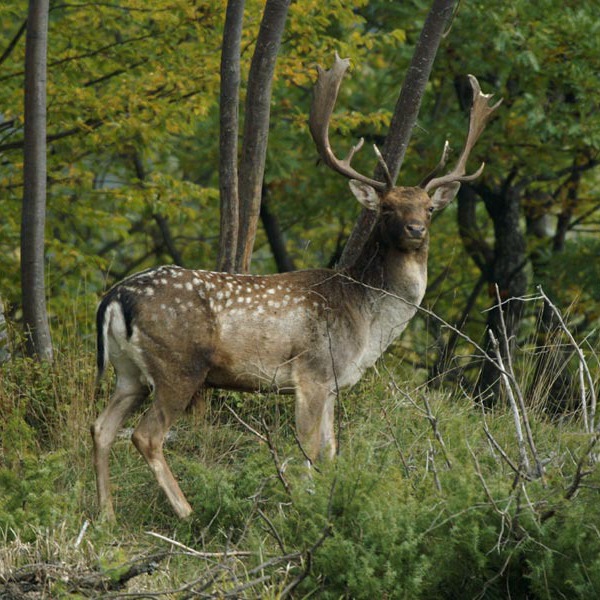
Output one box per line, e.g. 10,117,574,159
92,55,499,517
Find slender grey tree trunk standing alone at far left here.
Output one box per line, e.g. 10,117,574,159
21,0,53,361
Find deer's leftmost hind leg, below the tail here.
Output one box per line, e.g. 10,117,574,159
92,365,150,520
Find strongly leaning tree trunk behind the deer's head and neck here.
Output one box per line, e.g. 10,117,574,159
340,0,456,268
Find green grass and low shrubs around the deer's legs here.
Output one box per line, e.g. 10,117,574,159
0,330,600,599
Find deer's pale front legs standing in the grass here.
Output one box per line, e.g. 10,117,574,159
296,377,336,463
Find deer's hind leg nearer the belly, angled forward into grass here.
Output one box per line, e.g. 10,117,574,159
131,382,197,519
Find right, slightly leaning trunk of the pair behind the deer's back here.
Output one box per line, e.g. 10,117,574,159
235,0,290,273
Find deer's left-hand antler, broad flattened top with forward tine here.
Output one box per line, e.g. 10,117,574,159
308,52,388,191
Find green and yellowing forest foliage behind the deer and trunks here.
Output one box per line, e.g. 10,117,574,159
0,0,600,346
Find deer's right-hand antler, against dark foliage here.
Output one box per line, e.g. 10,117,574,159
425,75,502,192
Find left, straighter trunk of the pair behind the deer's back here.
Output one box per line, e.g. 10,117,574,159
217,0,245,272
